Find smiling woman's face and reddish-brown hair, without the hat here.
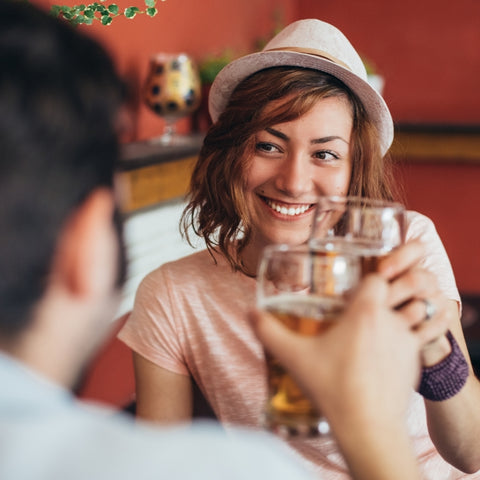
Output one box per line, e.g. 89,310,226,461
179,65,392,275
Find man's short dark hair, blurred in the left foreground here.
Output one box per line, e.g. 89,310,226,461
0,0,126,335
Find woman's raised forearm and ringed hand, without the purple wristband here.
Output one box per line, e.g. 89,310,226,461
379,241,480,473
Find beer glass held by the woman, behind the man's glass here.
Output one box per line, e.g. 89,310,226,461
309,196,405,275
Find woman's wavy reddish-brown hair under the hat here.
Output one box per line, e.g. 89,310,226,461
181,67,393,271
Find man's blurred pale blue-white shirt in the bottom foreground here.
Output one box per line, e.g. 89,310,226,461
0,353,311,480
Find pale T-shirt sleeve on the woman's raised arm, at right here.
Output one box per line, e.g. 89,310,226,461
406,212,460,304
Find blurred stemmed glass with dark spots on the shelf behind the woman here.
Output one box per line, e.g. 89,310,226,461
144,53,201,145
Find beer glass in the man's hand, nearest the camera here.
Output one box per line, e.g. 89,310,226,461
257,245,360,437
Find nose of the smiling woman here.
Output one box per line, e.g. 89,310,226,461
276,154,312,198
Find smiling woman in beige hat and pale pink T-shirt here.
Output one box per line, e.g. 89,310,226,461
119,16,480,480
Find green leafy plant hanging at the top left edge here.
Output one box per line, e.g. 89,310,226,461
50,0,161,25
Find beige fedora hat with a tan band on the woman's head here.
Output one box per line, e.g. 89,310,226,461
208,19,393,154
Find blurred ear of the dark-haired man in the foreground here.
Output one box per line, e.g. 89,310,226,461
53,188,119,297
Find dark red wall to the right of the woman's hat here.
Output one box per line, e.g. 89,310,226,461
298,0,480,125
